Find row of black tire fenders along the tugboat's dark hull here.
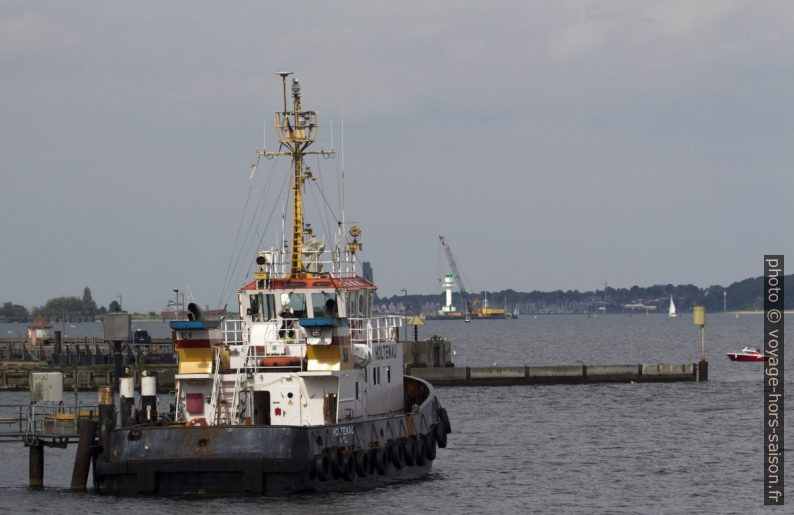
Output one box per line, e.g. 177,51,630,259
312,408,452,481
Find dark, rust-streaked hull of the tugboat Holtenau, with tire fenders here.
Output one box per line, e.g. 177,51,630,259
94,377,450,496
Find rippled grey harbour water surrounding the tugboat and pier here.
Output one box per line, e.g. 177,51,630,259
0,314,794,514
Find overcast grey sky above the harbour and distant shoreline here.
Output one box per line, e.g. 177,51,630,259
0,0,794,311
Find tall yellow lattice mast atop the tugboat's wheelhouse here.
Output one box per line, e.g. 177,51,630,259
257,72,334,279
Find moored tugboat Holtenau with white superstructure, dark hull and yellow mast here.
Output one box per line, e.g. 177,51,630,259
94,72,451,495
